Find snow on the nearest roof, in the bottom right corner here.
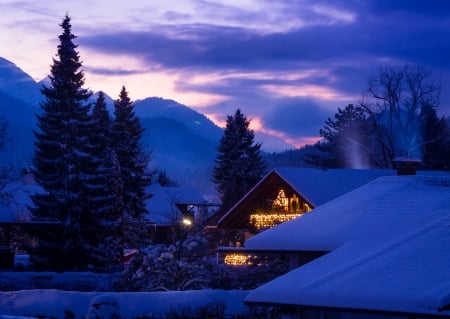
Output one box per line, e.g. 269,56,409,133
245,215,450,316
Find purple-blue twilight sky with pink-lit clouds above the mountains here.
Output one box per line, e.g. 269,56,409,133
0,0,450,146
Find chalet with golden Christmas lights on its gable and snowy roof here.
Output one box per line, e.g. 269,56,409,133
217,167,396,263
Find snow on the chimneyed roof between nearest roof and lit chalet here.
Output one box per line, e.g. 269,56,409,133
245,174,450,251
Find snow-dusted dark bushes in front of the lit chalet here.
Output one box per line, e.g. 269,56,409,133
115,240,288,291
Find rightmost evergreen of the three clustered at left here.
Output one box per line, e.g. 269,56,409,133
111,87,151,247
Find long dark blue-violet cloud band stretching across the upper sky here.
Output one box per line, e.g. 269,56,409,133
77,1,450,70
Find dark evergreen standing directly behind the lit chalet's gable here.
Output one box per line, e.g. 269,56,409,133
213,109,265,213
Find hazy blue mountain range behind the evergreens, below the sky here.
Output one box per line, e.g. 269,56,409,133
0,58,292,195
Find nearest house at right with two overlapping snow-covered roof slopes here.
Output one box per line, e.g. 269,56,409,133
245,173,450,318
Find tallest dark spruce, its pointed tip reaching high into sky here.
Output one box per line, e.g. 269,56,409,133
31,15,93,270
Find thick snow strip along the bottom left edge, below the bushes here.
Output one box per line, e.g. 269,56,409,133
0,289,248,319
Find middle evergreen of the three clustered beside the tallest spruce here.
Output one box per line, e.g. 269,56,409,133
88,92,123,272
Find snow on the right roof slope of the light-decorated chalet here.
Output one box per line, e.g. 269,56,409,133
274,167,396,207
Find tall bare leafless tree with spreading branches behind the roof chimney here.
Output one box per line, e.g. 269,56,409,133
361,65,441,168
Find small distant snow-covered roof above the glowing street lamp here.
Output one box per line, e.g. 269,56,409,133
145,183,206,225
